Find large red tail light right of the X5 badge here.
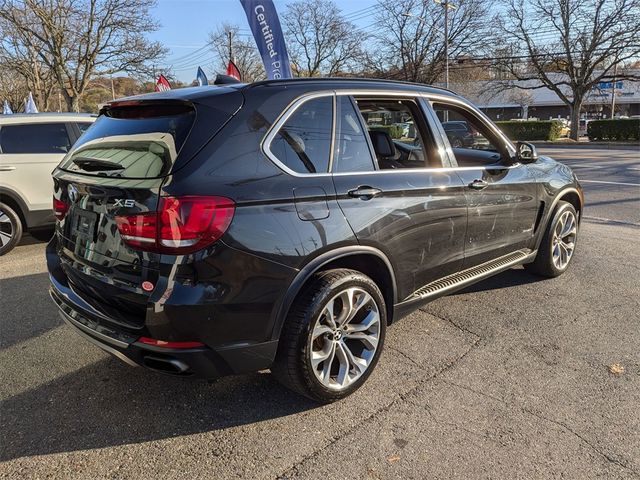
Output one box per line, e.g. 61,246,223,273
116,197,235,255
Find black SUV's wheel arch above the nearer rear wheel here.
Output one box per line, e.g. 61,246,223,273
272,245,397,340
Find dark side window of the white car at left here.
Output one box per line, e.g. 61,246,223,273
0,123,71,153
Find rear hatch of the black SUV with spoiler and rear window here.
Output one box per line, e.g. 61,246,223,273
53,89,242,329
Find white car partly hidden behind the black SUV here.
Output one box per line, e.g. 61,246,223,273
0,113,95,255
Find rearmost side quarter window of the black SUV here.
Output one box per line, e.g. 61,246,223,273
269,97,333,173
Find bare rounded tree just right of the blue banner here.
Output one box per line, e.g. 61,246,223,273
282,0,364,77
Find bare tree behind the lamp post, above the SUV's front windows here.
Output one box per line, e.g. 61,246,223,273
368,0,488,83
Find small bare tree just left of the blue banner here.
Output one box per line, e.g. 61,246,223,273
209,23,266,82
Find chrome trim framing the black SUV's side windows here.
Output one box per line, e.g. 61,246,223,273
260,89,520,177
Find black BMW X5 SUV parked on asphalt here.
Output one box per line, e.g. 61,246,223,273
47,79,583,402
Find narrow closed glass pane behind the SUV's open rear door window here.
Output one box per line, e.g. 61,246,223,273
333,95,374,172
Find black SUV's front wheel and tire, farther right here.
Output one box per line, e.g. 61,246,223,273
524,201,578,278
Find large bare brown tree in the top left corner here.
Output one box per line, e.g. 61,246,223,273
0,0,165,111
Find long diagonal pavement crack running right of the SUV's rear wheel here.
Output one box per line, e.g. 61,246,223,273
276,330,481,480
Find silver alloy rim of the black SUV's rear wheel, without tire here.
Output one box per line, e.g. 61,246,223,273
310,287,380,390
